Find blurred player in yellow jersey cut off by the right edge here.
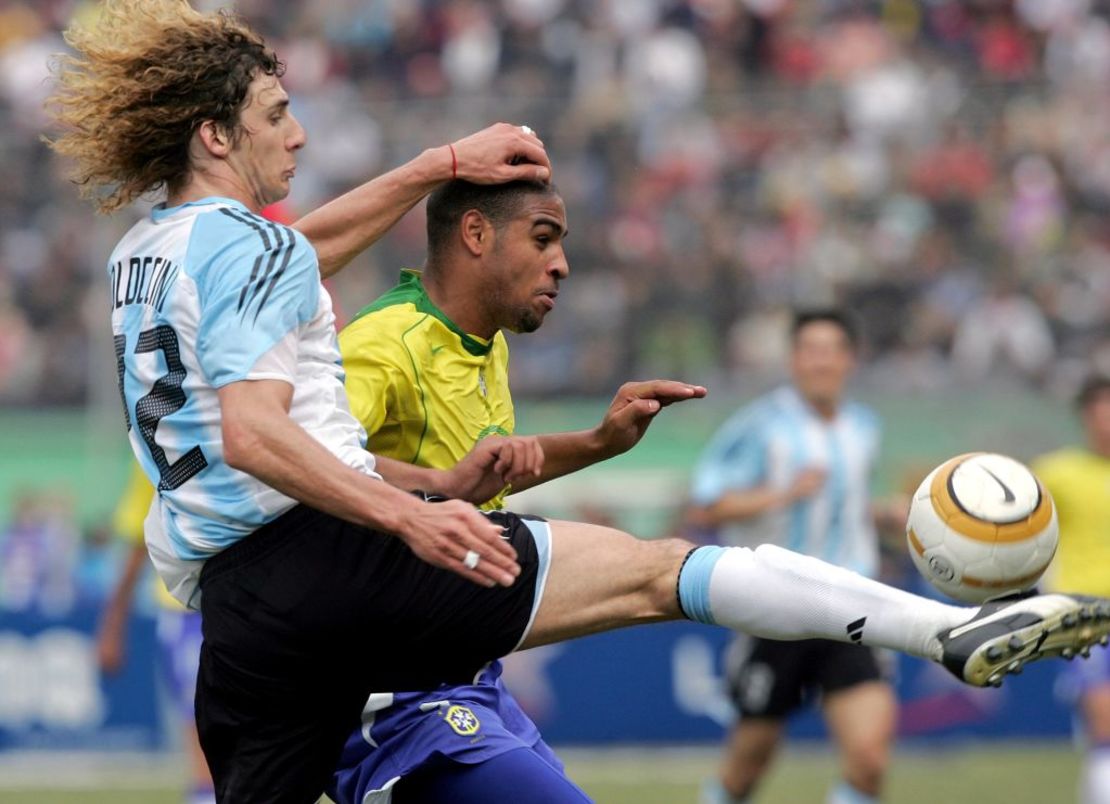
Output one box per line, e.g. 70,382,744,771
1033,375,1110,804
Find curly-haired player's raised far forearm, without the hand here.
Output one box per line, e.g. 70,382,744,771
293,145,452,279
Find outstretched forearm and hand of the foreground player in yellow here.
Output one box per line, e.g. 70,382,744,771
508,380,706,491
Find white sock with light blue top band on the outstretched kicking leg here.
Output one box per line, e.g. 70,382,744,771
678,544,977,661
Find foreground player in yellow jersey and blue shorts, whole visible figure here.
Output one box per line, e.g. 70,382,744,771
330,182,689,804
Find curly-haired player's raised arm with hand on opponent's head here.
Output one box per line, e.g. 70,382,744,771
293,123,551,279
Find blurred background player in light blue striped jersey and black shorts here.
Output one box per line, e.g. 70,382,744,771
690,309,896,804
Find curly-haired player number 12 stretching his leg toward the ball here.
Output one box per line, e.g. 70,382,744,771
45,0,1110,804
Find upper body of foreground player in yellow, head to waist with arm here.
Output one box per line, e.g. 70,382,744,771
340,181,670,515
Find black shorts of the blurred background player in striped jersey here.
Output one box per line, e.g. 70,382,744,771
726,636,884,720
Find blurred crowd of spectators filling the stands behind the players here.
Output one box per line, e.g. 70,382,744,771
0,0,1110,405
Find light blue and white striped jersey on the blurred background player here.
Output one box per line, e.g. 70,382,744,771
690,386,880,576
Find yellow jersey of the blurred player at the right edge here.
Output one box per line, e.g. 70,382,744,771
1033,449,1110,596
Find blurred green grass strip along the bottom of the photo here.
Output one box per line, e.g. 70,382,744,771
0,743,1080,804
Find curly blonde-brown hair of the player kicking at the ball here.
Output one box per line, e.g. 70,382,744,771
47,0,284,213
